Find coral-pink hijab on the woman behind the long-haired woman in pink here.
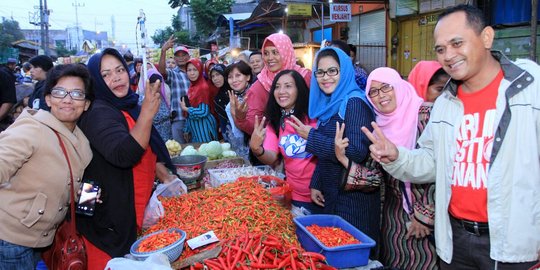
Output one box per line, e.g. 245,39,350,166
257,33,310,91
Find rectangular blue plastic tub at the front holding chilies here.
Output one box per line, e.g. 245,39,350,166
294,215,375,268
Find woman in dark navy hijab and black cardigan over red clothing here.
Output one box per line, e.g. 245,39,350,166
77,48,176,269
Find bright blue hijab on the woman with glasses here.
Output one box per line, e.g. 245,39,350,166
309,47,371,125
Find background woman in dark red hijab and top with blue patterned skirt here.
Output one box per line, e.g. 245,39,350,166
180,59,218,143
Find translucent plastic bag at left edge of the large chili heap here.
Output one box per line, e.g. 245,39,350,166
142,178,187,229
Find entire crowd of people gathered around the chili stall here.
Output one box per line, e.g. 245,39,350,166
0,5,540,269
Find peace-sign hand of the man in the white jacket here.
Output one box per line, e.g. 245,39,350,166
362,122,399,163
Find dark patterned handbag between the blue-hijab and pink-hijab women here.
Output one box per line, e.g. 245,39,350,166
341,156,383,193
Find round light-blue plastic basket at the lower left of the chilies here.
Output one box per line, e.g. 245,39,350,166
129,228,186,262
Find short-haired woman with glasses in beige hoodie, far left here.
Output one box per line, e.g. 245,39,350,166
0,64,94,270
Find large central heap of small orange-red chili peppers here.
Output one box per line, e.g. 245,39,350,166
145,177,299,259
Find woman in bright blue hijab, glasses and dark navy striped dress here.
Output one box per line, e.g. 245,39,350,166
292,47,381,249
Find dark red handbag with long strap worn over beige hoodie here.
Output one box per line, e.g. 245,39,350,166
41,131,87,270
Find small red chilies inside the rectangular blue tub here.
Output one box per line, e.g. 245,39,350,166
306,224,361,247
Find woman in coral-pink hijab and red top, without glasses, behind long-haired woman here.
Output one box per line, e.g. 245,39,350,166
231,34,311,135
